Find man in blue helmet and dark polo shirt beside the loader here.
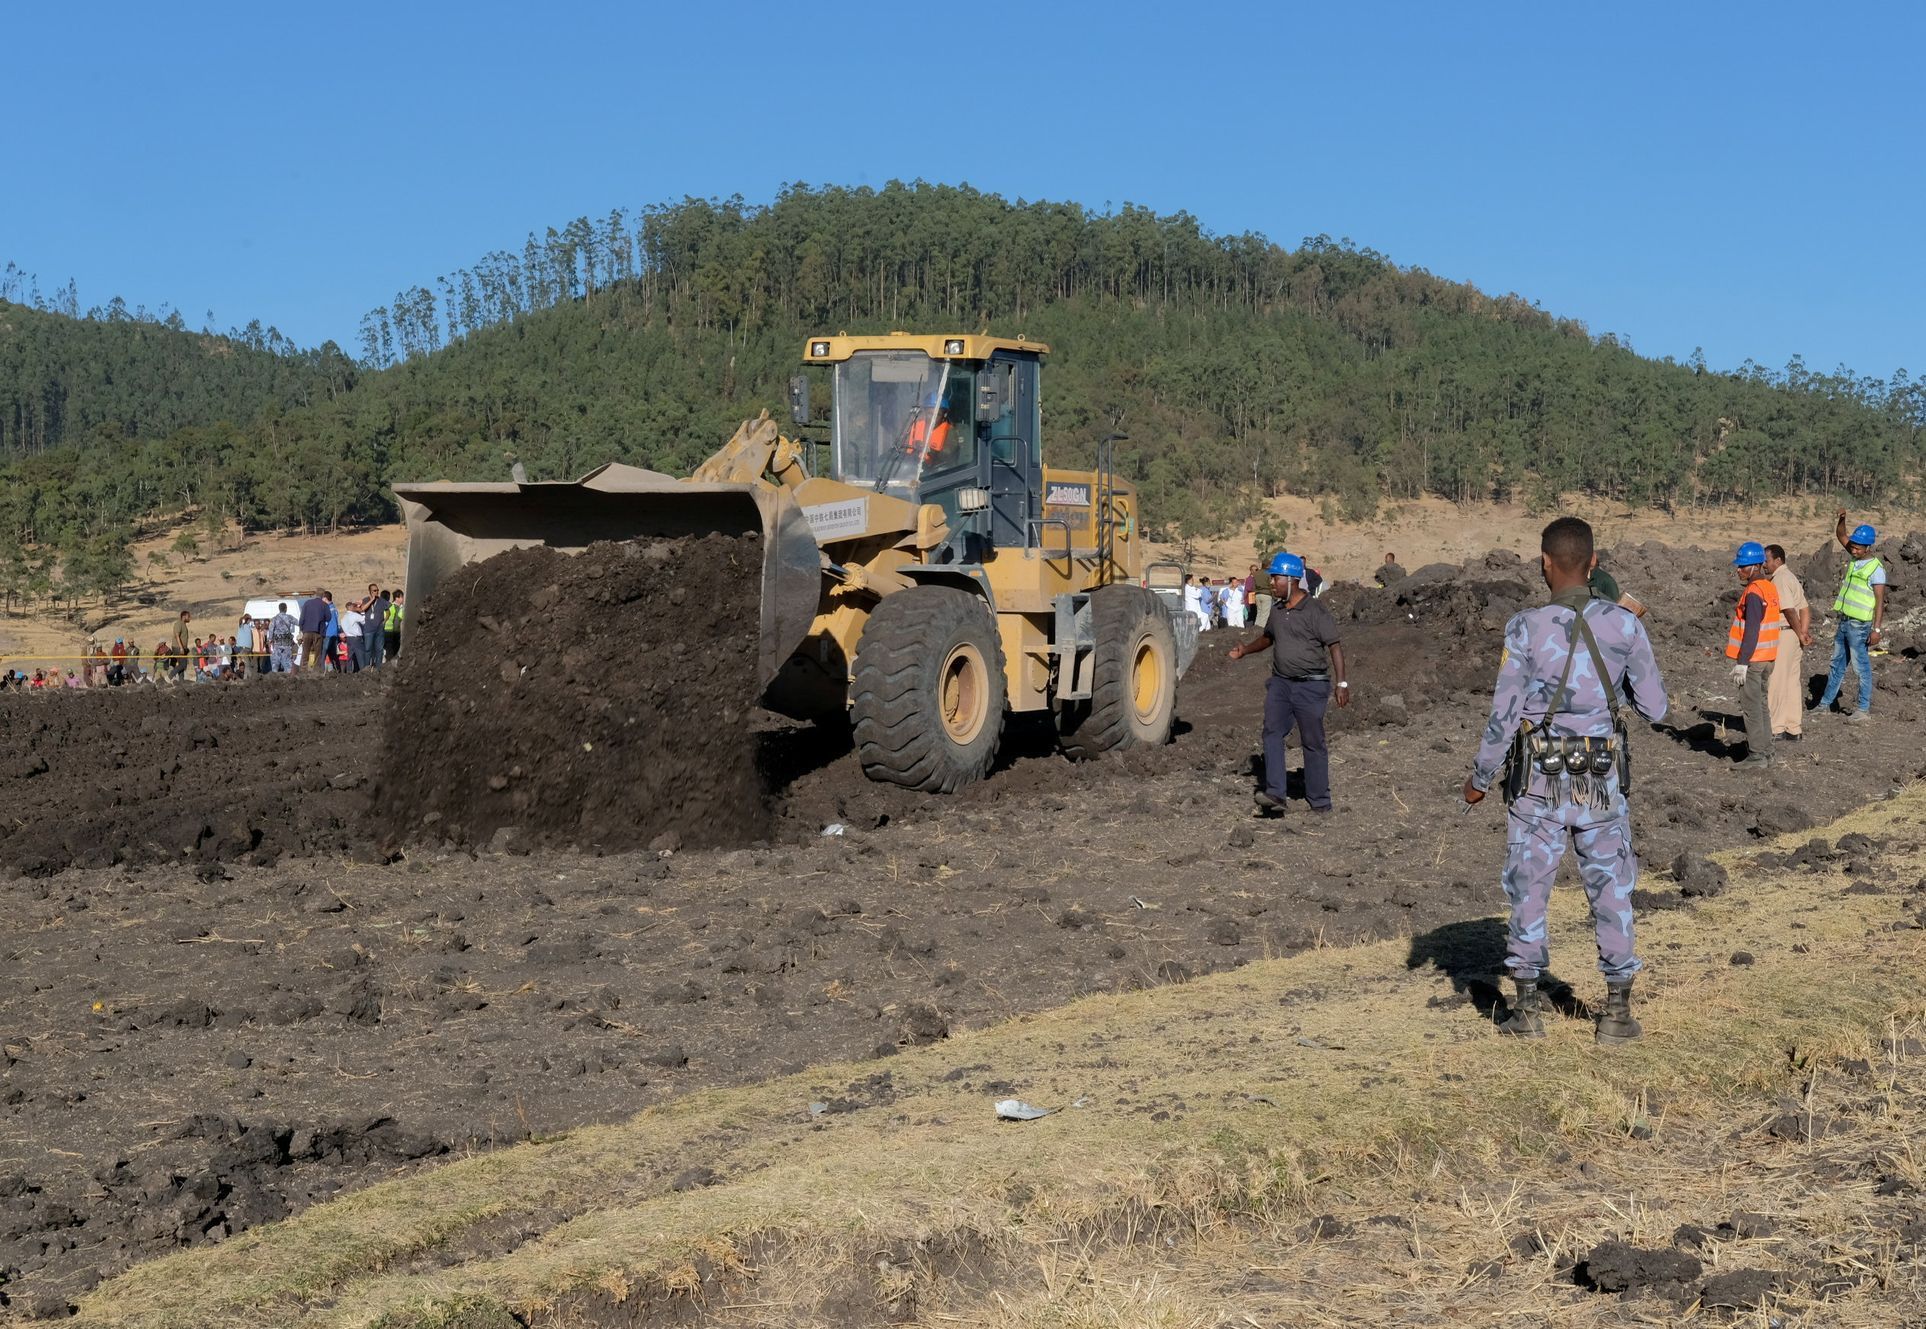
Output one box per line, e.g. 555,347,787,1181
1231,553,1350,813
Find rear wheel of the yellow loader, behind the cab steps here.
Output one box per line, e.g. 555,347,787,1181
1057,586,1177,761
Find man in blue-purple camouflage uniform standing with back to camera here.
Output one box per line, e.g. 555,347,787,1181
1464,516,1666,1044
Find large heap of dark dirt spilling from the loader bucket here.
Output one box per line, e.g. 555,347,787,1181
376,534,768,849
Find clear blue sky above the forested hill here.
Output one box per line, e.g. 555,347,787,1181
0,0,1926,376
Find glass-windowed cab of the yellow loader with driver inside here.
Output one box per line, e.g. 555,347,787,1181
805,333,1048,562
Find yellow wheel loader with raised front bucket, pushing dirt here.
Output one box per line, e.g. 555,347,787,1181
395,333,1196,792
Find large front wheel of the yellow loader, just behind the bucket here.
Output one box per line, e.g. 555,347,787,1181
849,586,1005,794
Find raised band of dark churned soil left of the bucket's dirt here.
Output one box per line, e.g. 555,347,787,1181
0,672,379,876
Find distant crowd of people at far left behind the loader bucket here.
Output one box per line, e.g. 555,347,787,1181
0,582,406,691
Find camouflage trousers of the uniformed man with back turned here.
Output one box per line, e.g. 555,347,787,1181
1504,774,1641,980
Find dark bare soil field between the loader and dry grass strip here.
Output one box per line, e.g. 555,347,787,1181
0,541,1920,1314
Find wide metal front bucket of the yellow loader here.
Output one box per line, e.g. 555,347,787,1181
395,464,822,688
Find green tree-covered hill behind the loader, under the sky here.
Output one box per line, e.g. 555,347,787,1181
0,185,1926,597
